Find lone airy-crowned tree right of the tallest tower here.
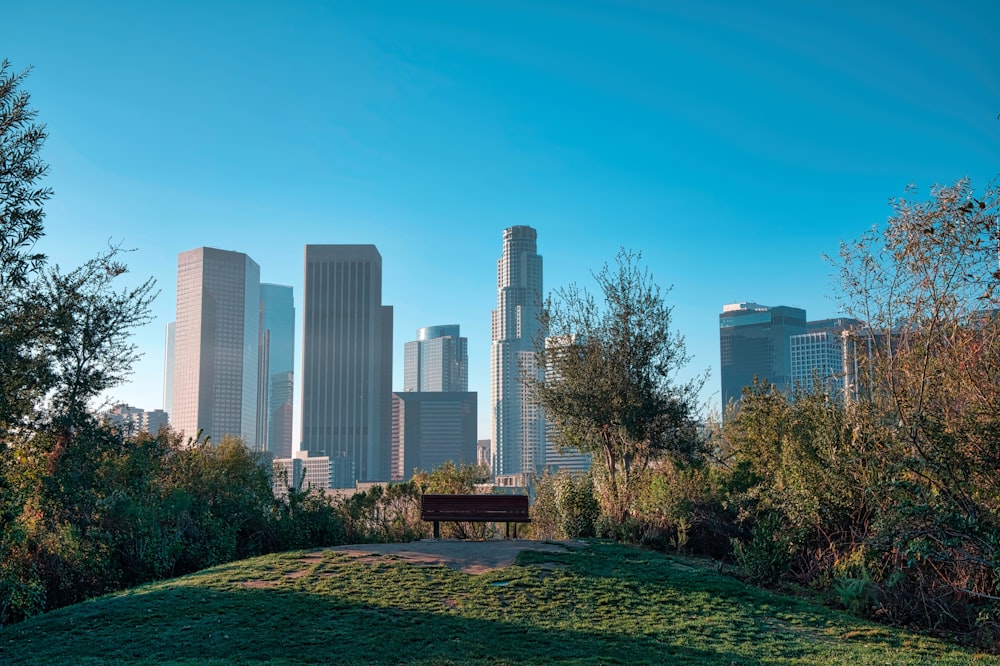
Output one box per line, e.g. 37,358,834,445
528,249,705,525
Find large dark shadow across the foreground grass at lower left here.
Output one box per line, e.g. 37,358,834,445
0,587,750,664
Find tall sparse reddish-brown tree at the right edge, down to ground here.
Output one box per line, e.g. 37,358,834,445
820,180,1000,640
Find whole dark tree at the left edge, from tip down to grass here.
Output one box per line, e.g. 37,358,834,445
0,61,155,623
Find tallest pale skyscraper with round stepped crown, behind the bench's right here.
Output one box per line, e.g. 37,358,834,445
490,226,545,475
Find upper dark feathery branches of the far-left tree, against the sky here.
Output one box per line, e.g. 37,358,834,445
0,60,156,438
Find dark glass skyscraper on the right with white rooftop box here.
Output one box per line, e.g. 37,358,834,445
719,303,806,408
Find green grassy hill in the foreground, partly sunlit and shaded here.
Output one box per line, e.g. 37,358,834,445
0,542,1000,666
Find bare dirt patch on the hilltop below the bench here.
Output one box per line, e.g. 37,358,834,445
331,539,587,574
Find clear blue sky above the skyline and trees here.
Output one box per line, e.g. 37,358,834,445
0,0,1000,437
